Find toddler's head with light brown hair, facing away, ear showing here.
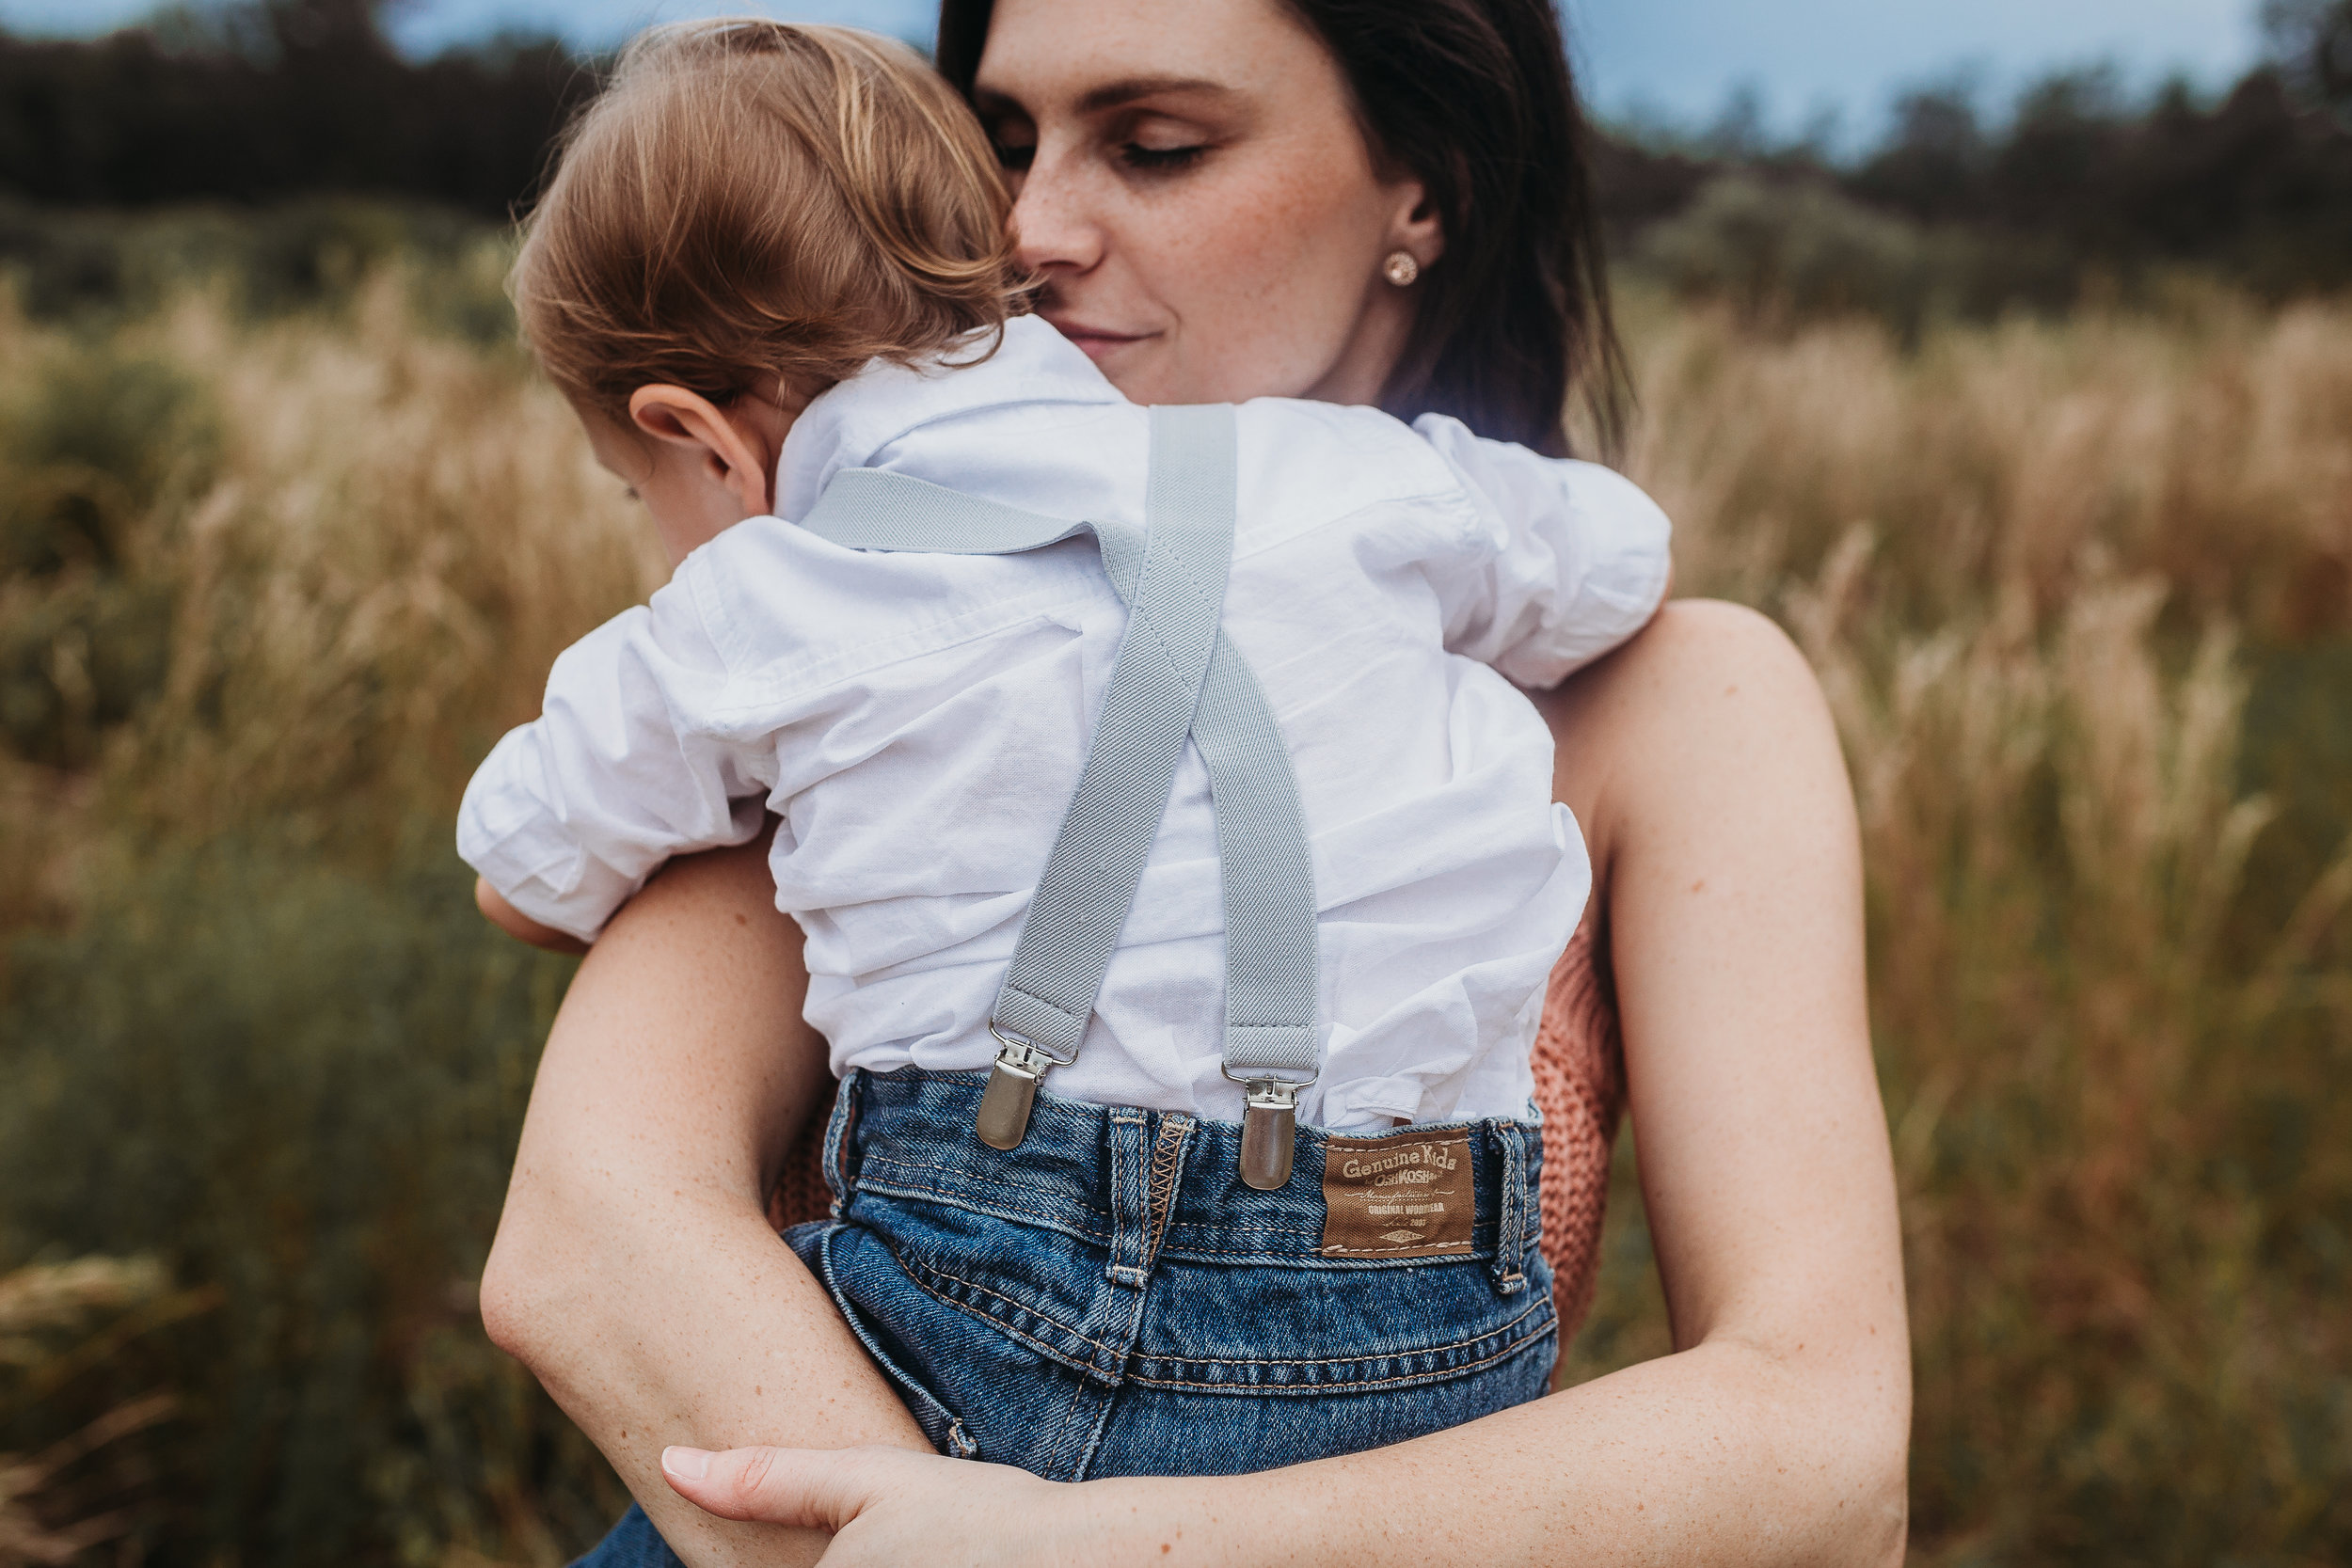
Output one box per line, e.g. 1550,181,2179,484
513,19,1024,557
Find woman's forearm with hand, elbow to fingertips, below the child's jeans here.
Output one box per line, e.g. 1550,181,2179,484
671,1323,1905,1568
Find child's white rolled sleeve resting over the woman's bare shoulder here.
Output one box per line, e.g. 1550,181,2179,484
1414,414,1673,687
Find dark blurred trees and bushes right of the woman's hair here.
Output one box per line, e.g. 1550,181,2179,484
1599,0,2352,331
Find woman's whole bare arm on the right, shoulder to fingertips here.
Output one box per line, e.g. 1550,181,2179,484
673,604,1910,1568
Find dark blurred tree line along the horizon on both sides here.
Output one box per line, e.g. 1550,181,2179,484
0,0,2352,306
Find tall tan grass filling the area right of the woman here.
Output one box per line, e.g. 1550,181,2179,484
1581,288,2352,1563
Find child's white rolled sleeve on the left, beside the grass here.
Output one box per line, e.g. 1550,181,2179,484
456,573,767,941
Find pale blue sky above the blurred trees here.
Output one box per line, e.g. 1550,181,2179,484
0,0,2261,146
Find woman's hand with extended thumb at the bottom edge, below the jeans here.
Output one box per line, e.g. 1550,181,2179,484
661,1449,1124,1568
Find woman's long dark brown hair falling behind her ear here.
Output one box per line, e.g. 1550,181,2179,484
939,0,1628,456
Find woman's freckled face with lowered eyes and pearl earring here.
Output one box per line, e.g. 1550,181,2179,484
974,0,1444,402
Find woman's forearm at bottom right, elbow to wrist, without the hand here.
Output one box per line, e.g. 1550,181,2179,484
1101,1338,1905,1568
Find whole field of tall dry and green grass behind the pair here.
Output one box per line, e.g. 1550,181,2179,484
0,239,2352,1566
